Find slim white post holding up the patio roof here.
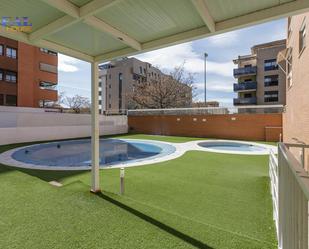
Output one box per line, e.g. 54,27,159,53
91,62,100,193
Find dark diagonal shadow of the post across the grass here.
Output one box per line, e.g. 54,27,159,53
96,192,213,249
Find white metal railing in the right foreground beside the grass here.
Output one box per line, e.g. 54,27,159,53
269,143,309,249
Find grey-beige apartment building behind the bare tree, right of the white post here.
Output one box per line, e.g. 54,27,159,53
99,58,192,113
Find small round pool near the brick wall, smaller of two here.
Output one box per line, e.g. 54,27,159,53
198,140,273,154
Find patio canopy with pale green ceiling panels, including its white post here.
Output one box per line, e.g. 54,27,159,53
0,0,309,248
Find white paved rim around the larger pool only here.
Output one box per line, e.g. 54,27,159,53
0,138,184,171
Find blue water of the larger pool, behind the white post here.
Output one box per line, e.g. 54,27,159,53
12,139,175,167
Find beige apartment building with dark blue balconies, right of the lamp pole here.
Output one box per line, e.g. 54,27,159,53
233,40,286,105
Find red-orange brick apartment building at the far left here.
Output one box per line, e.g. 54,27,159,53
0,36,58,107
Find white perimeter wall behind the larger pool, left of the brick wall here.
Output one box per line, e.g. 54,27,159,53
0,107,128,145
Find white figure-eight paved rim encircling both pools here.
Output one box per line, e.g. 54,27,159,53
0,138,277,171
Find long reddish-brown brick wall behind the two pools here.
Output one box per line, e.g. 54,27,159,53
128,113,282,141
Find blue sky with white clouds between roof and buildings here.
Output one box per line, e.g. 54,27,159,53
58,19,286,106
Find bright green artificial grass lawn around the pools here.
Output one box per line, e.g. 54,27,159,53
0,136,277,249
